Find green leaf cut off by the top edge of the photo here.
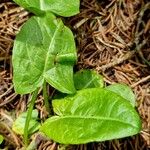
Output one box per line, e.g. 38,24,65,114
14,0,80,17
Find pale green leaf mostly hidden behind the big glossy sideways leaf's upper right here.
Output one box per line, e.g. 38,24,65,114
106,83,136,107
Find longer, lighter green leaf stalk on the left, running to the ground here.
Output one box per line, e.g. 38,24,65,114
24,89,38,147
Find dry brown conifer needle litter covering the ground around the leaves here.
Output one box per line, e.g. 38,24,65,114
0,0,150,150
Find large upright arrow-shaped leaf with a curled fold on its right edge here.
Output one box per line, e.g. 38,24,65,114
12,13,77,94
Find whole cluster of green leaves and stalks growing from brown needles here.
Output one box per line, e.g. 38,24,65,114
12,0,141,146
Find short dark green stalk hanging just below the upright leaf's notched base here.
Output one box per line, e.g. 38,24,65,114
43,82,51,113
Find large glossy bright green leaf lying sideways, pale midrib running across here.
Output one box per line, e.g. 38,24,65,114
40,88,141,144
